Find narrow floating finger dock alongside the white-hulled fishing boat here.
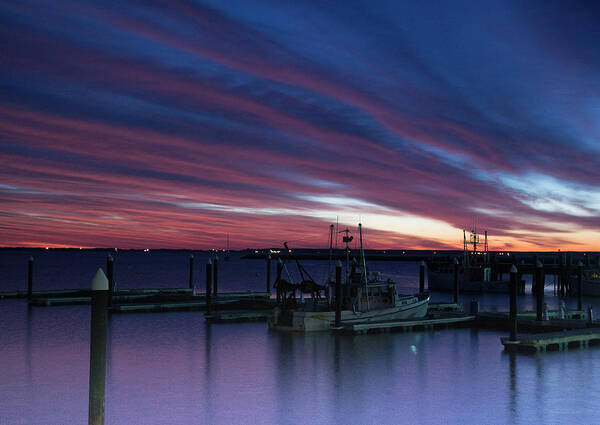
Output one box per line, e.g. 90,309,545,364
332,314,475,335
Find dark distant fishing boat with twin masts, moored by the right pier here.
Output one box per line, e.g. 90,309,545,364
427,229,510,293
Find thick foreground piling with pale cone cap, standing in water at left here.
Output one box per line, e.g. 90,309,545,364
88,269,109,425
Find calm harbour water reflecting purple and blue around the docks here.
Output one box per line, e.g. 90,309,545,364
0,251,600,424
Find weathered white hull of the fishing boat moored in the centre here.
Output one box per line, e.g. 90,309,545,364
269,298,429,332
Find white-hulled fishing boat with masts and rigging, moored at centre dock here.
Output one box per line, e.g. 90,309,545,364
269,223,429,332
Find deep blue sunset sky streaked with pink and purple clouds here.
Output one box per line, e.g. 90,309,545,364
0,0,600,251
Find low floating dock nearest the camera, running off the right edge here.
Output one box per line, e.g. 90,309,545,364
500,328,600,353
